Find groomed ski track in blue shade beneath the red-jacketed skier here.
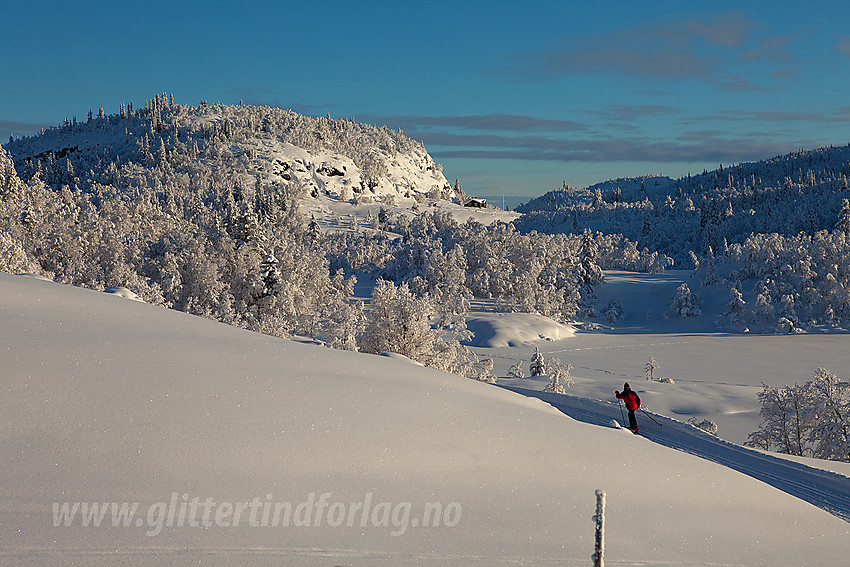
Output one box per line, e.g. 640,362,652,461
501,386,850,522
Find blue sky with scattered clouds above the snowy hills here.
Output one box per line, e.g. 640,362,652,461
0,0,850,199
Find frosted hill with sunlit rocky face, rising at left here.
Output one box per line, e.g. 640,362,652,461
5,95,459,206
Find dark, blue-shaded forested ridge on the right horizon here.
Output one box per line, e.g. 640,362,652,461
516,146,850,262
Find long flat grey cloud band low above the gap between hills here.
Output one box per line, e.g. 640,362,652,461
356,104,826,169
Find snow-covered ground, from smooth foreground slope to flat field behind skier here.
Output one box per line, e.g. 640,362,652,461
0,274,850,566
